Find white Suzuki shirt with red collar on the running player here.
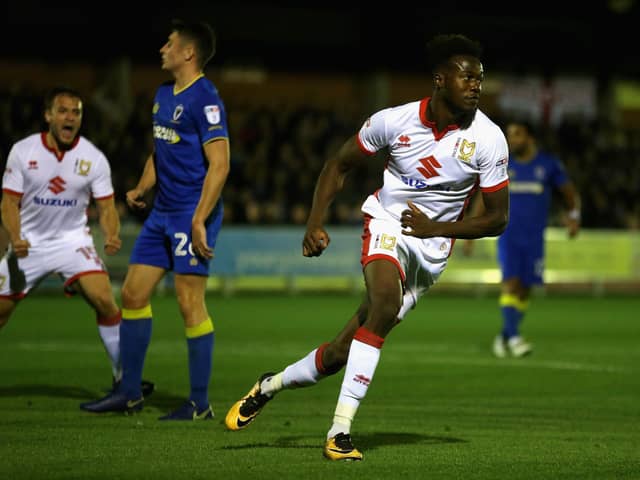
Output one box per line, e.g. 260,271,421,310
358,97,509,222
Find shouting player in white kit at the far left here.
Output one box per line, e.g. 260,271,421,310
0,87,150,398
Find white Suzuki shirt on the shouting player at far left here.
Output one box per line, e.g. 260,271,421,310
2,132,113,246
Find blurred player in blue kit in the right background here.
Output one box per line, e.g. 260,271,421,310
467,120,580,358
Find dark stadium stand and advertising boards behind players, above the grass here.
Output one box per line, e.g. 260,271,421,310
0,0,640,293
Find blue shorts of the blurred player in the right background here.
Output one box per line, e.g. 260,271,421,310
497,235,544,286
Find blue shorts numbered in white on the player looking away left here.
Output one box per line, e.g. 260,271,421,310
129,205,222,276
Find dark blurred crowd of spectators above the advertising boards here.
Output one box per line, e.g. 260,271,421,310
0,83,640,230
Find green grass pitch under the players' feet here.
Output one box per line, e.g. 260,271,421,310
0,292,640,480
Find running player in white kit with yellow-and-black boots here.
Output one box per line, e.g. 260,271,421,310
225,35,509,460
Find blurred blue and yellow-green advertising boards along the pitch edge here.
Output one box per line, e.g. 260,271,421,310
82,223,640,295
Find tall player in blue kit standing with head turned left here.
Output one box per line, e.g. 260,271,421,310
82,20,230,420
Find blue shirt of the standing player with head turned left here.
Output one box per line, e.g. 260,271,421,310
153,75,229,213
